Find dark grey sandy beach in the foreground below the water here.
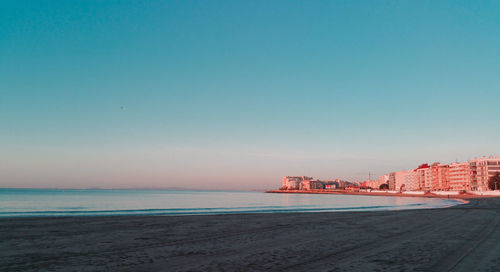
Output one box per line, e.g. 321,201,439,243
0,198,500,271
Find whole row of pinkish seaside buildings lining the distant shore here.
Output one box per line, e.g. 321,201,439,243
280,157,500,192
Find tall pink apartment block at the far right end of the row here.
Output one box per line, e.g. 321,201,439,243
469,157,500,191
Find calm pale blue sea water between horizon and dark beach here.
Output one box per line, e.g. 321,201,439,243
0,189,461,217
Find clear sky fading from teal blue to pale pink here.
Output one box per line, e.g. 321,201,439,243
0,0,500,190
